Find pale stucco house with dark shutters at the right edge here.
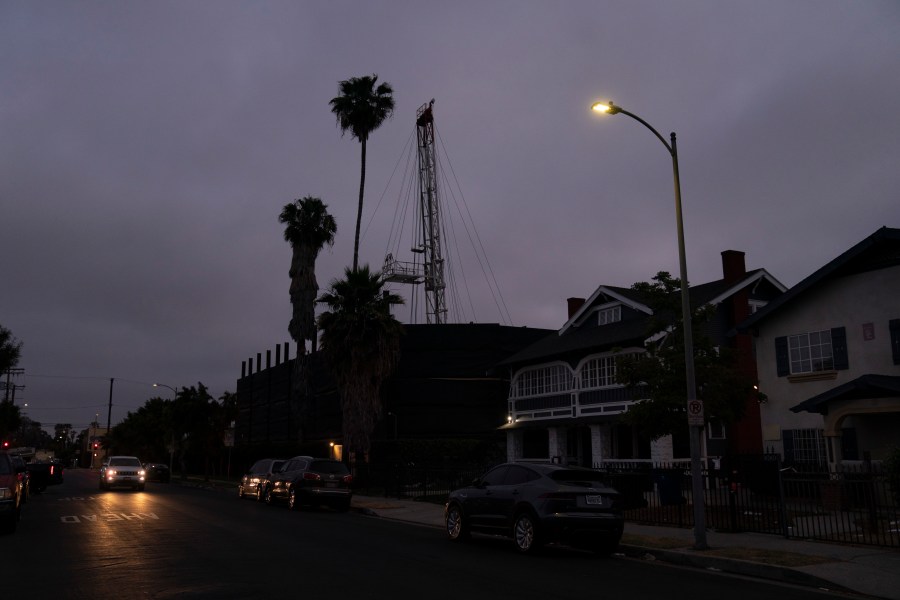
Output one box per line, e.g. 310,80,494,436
738,227,900,469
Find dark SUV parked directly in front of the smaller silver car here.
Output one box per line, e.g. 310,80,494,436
265,456,353,511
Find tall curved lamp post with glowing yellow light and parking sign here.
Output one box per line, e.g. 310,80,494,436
591,102,709,550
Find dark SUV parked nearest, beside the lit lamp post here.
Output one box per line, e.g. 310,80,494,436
444,463,624,554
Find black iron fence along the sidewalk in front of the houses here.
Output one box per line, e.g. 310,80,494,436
355,455,900,548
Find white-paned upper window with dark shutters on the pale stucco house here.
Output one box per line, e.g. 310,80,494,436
775,327,850,377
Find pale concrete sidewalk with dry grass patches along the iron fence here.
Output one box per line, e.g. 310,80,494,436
352,496,900,600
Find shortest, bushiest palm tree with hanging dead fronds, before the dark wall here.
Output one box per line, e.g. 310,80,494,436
319,265,403,464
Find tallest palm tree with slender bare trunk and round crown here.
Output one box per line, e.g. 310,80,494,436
328,75,394,271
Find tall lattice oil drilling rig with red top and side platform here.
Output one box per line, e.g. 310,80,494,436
382,98,447,325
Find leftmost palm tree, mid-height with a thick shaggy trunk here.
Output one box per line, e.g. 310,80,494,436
278,196,337,354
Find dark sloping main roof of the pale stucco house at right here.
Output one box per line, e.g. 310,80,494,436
737,227,900,332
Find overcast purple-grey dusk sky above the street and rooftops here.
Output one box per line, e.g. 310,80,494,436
0,0,900,429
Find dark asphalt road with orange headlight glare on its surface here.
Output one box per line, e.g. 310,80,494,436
0,469,852,600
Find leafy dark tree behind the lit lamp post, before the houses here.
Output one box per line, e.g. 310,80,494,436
616,271,753,439
